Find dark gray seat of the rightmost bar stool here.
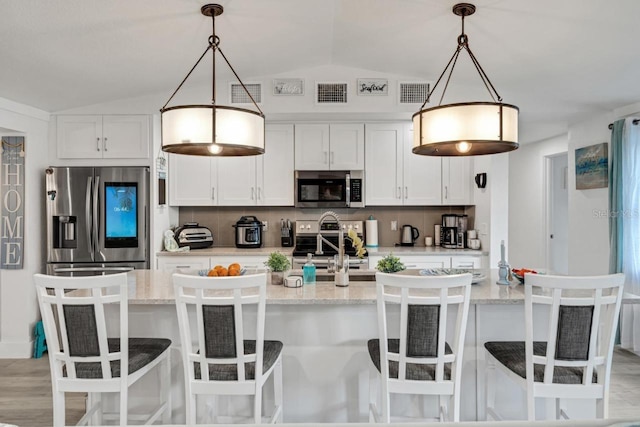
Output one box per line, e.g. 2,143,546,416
484,341,598,384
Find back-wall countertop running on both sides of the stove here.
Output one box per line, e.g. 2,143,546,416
156,246,489,256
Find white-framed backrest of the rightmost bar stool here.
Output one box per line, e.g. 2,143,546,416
525,274,624,385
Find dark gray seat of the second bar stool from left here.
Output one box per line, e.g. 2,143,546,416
194,340,283,381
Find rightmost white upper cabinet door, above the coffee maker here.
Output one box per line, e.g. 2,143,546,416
442,157,473,205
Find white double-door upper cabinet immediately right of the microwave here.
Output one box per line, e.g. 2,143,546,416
365,123,442,206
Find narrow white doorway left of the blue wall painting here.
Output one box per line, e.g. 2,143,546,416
545,152,569,274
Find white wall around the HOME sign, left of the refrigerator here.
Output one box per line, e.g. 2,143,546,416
0,98,49,358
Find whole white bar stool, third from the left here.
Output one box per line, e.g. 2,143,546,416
367,272,472,423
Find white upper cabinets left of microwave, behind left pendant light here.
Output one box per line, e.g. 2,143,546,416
169,124,294,206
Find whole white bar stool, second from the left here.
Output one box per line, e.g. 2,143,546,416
173,273,283,425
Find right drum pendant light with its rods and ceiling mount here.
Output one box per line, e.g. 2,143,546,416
412,3,519,156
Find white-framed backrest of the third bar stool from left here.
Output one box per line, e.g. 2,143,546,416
376,272,472,382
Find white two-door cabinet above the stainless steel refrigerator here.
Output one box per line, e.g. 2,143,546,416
57,115,150,159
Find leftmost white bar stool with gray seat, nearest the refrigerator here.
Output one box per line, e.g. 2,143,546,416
34,273,171,427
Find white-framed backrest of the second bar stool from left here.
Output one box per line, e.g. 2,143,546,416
173,273,267,383
